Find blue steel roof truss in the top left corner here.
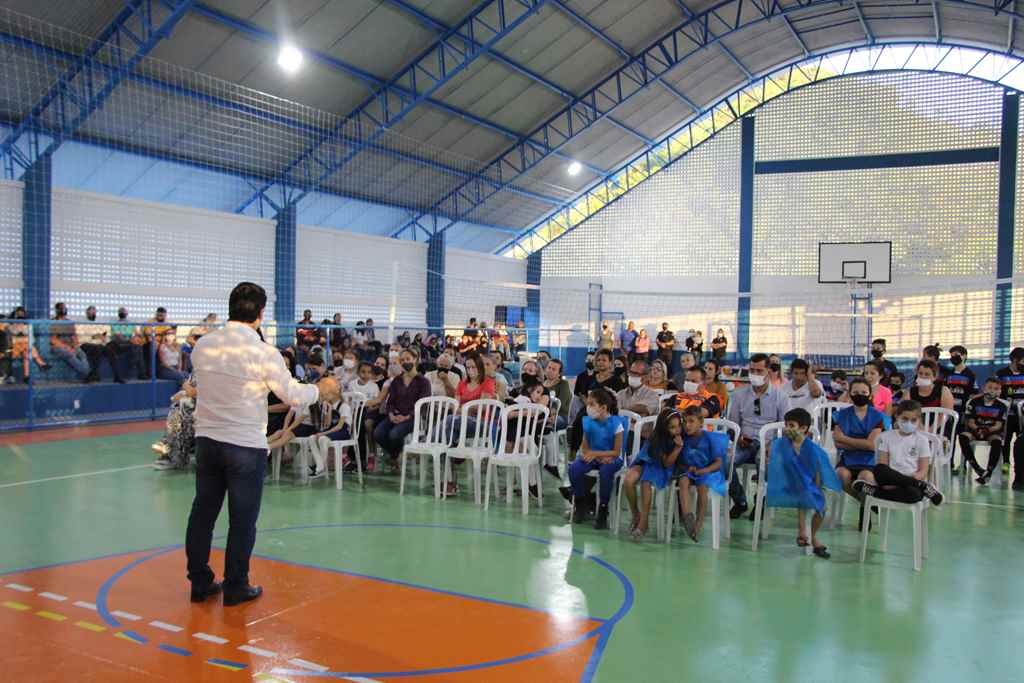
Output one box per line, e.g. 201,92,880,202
0,0,193,176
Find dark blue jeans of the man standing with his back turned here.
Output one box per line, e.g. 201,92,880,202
185,436,266,592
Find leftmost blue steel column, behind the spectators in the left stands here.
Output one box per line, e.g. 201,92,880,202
22,155,53,318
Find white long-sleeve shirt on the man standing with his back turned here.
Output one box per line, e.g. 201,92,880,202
191,322,319,449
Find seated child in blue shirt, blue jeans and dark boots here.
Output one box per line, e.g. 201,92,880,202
569,387,628,529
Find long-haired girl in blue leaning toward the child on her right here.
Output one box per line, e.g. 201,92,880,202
623,409,684,541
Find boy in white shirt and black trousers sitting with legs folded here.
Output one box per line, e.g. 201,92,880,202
854,400,942,505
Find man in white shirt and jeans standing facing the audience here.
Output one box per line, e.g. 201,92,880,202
185,283,340,606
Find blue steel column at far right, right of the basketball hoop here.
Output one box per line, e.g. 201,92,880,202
993,92,1020,360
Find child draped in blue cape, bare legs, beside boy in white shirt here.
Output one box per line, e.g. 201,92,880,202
765,408,843,559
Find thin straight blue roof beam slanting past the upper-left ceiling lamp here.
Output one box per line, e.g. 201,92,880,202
193,2,608,175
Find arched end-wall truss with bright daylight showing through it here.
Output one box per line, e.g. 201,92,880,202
495,40,1024,258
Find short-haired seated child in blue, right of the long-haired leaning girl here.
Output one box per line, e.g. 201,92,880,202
676,405,729,543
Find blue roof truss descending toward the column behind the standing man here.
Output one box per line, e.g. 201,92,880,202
236,0,547,213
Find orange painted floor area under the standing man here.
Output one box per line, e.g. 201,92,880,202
0,548,601,682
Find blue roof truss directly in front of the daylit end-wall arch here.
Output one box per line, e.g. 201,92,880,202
391,0,1020,242
